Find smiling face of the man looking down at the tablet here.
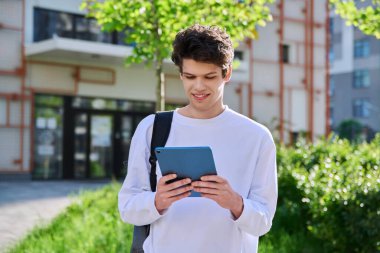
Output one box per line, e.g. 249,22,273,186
181,59,231,117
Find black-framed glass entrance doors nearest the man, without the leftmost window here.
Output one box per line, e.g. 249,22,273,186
72,111,141,179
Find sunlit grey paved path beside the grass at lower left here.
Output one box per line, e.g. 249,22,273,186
0,181,108,252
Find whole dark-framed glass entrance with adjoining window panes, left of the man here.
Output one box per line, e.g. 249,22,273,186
33,95,154,179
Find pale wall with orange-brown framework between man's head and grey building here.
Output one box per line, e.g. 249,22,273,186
236,0,329,143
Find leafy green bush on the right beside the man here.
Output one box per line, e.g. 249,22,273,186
274,135,380,252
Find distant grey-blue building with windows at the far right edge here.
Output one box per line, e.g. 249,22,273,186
330,5,380,135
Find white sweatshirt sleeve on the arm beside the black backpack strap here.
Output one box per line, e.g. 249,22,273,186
118,115,161,226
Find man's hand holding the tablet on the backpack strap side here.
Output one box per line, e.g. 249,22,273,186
154,174,193,214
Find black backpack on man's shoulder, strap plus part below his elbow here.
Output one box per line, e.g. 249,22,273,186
131,111,173,253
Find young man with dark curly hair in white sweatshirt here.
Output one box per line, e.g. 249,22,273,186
119,25,277,253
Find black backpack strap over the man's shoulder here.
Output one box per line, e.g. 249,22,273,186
149,111,173,192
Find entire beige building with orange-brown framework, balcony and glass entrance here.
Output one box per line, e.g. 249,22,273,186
0,0,329,182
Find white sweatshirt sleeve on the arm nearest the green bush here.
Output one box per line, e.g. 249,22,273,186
235,136,278,236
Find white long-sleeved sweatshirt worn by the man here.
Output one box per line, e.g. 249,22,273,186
119,108,277,253
